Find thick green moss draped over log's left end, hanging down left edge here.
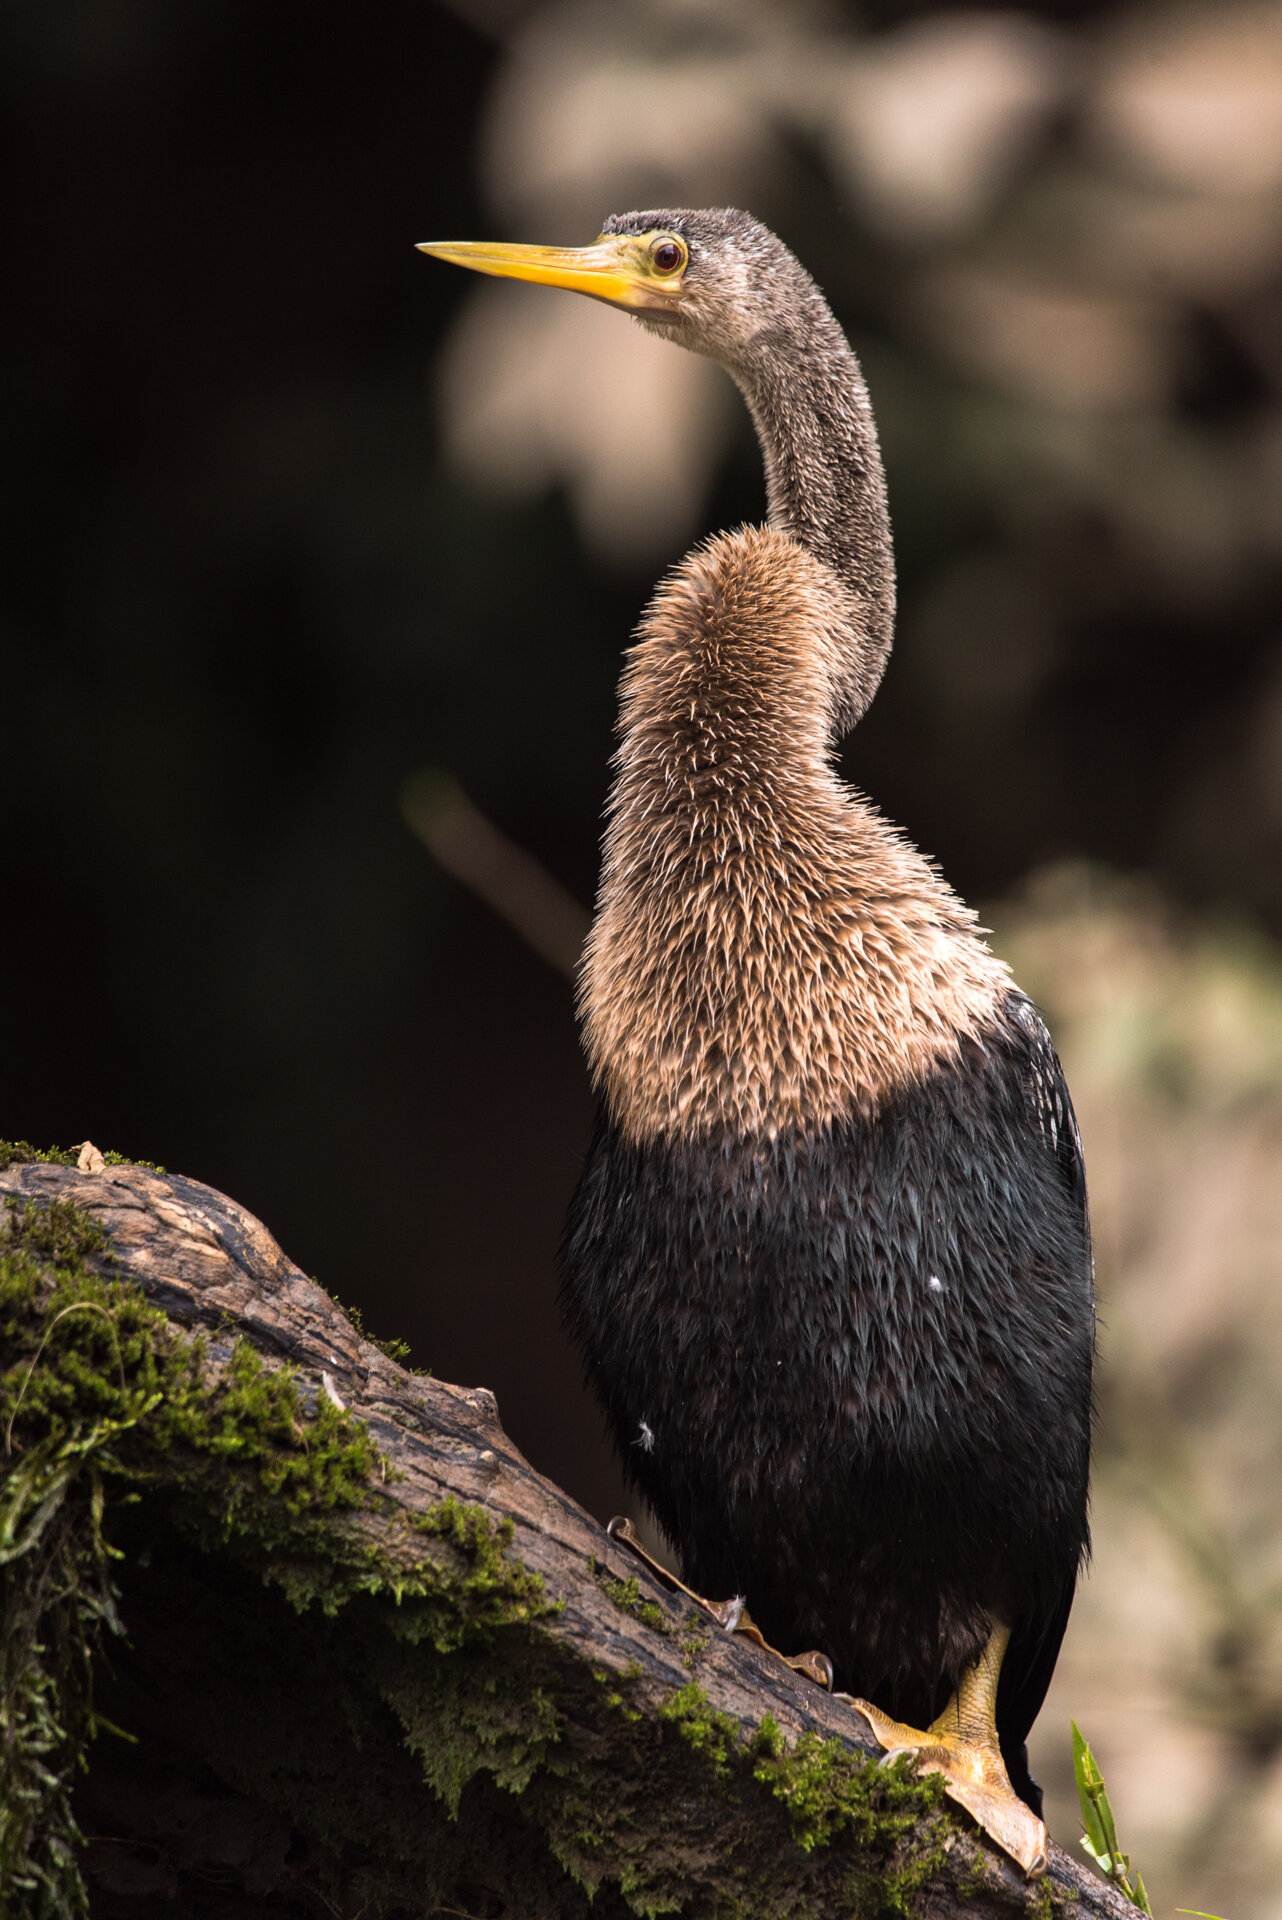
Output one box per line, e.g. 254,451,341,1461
0,1200,378,1914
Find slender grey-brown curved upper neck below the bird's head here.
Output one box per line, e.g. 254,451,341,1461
729,303,894,705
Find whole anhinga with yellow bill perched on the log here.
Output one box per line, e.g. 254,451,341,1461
426,209,1094,1874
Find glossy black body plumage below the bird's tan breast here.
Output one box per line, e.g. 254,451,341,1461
564,993,1094,1801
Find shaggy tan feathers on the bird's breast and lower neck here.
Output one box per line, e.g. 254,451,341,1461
583,530,1008,1140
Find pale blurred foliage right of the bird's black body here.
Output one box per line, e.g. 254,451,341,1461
994,866,1282,1920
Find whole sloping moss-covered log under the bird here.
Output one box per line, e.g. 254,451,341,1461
0,1148,1134,1920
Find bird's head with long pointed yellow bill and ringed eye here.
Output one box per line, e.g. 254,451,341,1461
420,207,814,371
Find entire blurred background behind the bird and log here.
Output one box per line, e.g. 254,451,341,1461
0,0,1282,1920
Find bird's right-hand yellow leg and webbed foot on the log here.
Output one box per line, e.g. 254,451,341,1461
852,1620,1046,1880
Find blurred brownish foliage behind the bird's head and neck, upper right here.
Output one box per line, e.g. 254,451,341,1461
438,0,1282,929
